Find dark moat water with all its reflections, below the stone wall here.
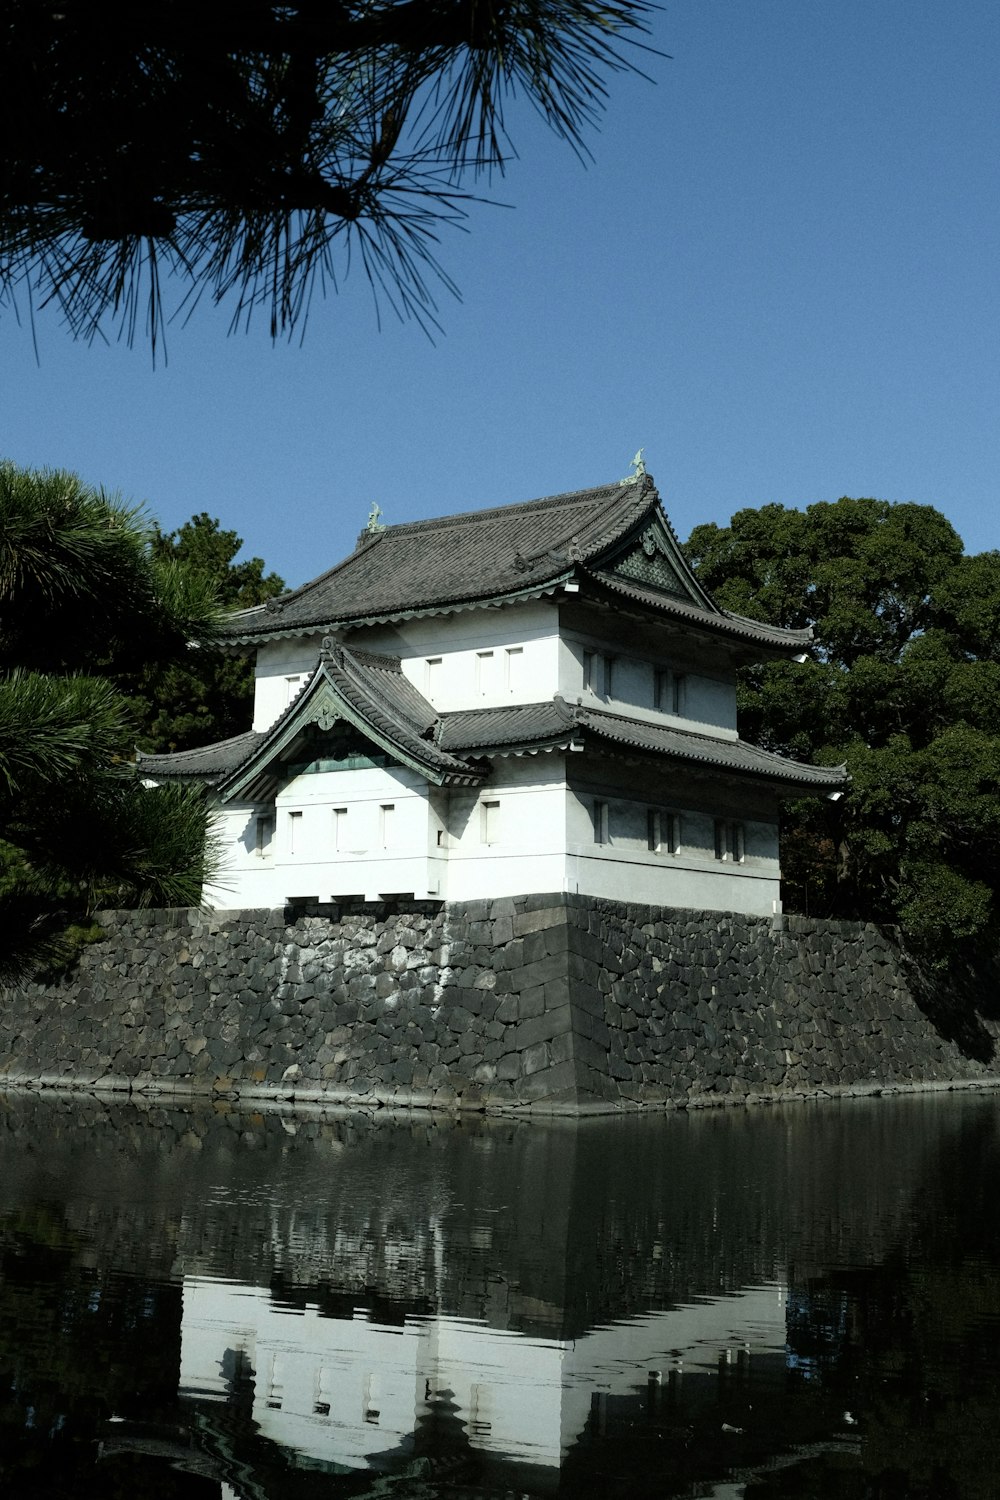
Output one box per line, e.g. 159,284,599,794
0,1094,1000,1500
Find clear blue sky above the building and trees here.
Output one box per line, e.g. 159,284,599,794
0,0,1000,585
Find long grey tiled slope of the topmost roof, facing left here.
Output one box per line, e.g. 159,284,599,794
225,476,660,642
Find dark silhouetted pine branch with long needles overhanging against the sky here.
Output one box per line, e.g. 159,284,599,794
0,0,654,339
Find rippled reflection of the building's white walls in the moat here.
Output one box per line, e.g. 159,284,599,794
180,1277,786,1469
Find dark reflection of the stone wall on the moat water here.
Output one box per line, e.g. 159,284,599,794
0,1092,997,1338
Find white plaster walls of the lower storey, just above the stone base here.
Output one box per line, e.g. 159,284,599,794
205,753,780,915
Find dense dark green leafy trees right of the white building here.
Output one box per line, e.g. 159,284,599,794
687,498,1000,962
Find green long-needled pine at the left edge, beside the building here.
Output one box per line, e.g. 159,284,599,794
0,464,219,980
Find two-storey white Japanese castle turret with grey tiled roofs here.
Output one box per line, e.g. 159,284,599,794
139,476,846,915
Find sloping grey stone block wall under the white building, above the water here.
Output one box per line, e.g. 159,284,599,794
0,896,997,1110
